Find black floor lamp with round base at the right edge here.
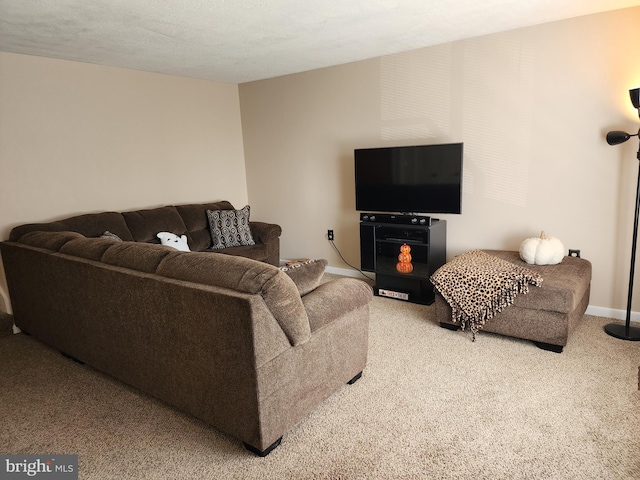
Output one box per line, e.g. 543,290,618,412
604,88,640,341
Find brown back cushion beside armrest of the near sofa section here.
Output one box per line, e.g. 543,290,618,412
157,252,311,345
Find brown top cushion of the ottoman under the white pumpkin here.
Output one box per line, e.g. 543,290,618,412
484,250,591,313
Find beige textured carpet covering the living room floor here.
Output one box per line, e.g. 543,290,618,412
0,290,640,479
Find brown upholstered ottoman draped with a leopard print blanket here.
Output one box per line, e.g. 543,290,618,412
435,250,591,353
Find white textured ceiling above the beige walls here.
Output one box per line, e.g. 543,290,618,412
0,0,640,83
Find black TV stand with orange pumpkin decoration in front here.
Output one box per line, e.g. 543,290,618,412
360,213,447,305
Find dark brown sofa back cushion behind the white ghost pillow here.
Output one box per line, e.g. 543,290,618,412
121,206,192,247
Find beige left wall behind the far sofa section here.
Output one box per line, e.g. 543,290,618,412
0,53,247,309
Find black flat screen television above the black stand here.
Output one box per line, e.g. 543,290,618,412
354,143,463,213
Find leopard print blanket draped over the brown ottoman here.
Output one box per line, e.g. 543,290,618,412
430,250,542,341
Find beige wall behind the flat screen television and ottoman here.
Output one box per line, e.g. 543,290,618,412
240,8,640,314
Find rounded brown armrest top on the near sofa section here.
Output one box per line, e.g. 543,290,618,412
302,278,373,333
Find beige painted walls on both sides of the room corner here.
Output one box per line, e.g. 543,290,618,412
0,8,640,314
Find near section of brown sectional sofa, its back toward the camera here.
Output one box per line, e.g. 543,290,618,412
0,201,372,455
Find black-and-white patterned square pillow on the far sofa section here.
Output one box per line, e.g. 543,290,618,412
207,205,256,250
